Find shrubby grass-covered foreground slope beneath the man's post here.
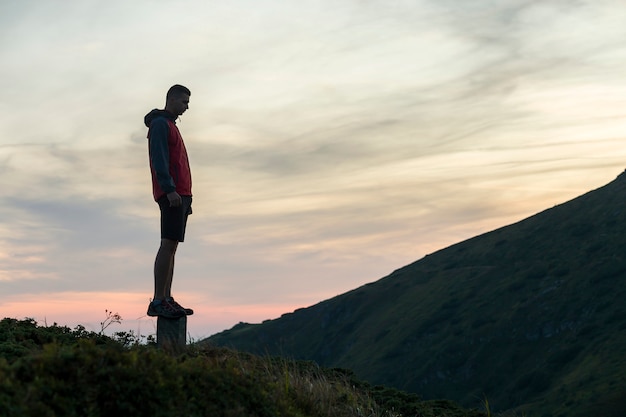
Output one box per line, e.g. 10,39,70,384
0,319,485,417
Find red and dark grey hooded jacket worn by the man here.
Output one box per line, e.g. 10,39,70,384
144,109,191,201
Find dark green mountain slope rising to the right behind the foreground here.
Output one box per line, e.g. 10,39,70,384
208,173,626,417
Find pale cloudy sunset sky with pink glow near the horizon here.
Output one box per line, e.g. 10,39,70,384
0,0,626,340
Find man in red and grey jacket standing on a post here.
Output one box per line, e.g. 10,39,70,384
144,84,193,318
